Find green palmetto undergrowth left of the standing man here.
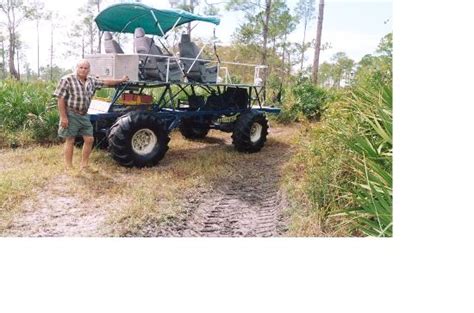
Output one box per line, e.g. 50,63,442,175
0,80,59,146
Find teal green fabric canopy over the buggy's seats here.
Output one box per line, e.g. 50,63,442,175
95,3,220,36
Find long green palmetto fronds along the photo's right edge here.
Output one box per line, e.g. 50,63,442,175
341,84,393,237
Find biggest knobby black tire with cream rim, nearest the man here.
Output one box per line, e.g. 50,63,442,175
107,111,170,167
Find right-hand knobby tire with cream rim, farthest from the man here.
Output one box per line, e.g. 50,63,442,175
232,111,268,153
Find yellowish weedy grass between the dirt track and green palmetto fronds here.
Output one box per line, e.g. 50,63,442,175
285,97,355,236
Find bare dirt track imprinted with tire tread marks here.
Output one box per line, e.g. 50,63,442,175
155,127,292,237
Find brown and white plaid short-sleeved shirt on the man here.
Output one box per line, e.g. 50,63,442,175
53,74,104,115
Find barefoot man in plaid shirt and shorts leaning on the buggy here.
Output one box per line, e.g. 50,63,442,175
54,60,128,172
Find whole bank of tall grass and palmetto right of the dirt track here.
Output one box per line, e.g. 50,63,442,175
287,81,393,237
